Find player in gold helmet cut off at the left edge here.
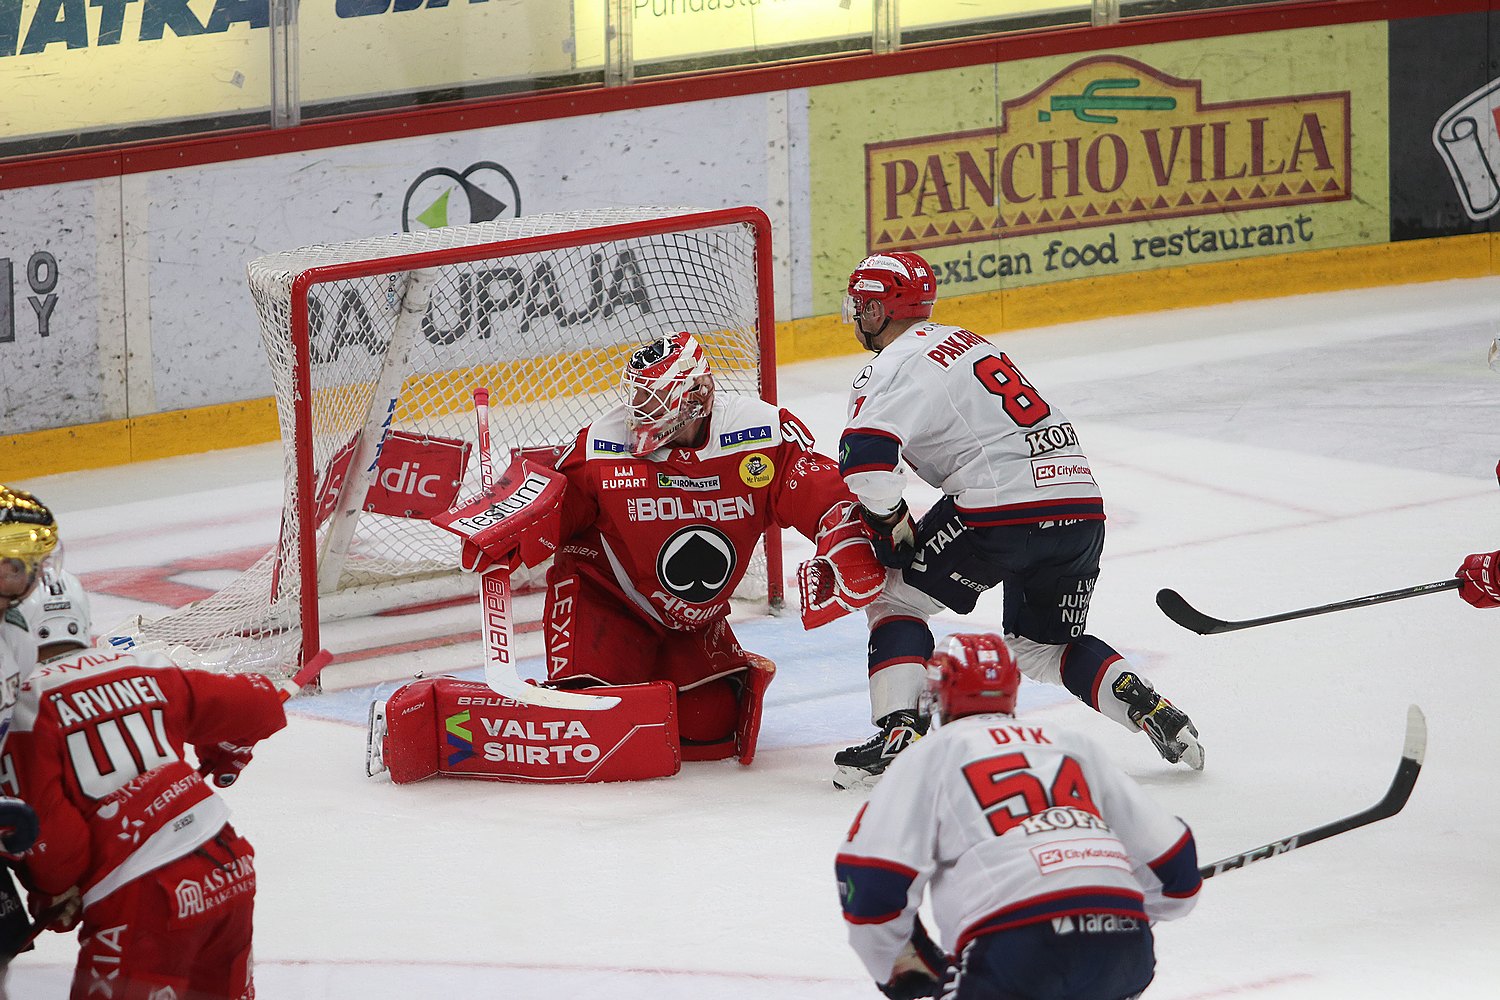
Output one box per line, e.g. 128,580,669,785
0,486,57,971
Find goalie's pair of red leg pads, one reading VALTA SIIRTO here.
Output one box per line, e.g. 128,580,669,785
366,654,776,784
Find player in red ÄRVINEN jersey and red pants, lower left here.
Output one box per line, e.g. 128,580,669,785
5,576,287,1000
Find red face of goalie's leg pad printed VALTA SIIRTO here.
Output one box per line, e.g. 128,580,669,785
429,678,681,784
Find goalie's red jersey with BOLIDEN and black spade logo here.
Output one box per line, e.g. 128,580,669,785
554,393,854,631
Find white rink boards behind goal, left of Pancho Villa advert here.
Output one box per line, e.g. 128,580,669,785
0,91,807,435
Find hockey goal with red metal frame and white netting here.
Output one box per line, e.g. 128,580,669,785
122,207,782,684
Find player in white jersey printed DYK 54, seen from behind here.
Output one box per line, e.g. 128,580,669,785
836,634,1203,1000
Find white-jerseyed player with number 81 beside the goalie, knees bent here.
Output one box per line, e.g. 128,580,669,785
836,252,1203,784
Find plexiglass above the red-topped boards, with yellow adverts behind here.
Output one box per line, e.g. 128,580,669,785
0,0,1290,157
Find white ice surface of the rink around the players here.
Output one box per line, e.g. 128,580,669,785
9,279,1500,1000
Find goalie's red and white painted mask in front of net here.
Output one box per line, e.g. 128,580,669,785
620,333,714,457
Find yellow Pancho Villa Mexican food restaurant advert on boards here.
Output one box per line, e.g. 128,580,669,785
809,24,1389,309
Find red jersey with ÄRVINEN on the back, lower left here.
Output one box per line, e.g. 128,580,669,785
5,649,287,907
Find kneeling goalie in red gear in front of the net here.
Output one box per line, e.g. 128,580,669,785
378,333,885,781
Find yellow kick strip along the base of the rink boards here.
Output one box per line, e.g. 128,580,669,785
0,234,1500,483
